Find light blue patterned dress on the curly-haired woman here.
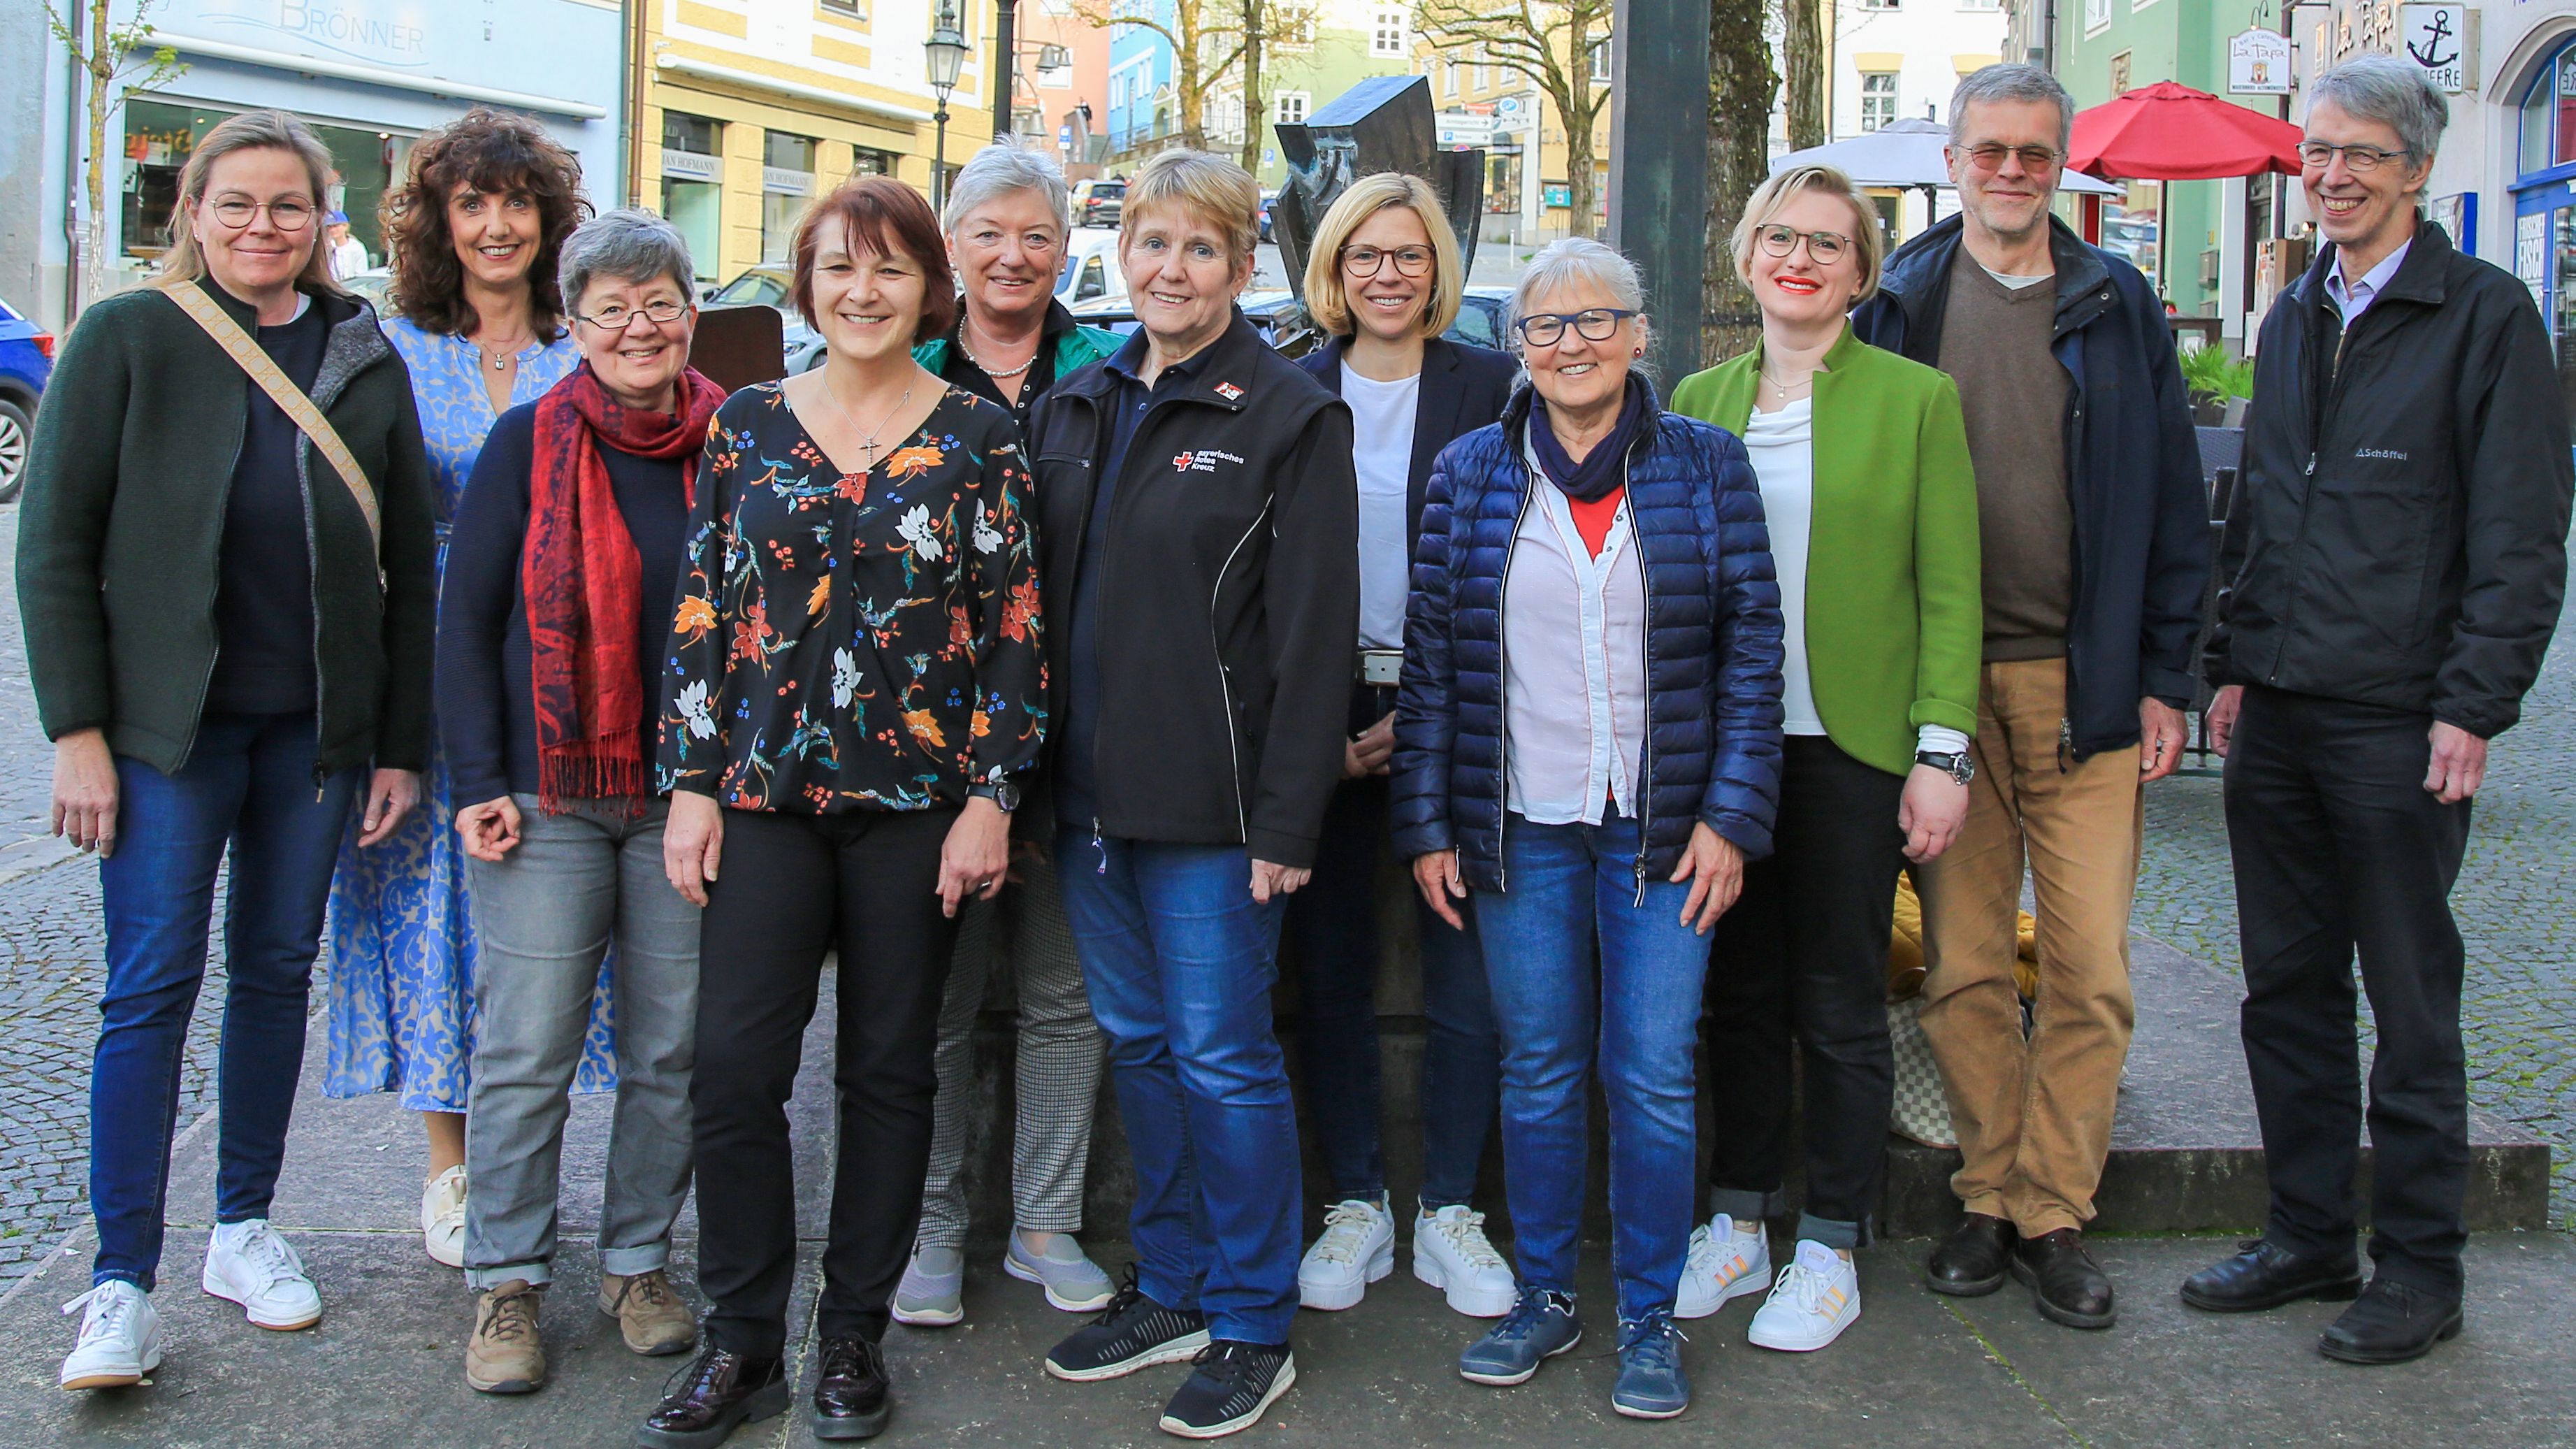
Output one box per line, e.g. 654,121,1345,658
322,317,618,1111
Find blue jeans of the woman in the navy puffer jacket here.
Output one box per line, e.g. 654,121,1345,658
1473,815,1708,1322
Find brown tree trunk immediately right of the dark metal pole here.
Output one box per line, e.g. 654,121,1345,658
1700,0,1780,366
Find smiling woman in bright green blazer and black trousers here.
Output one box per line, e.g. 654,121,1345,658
1672,168,1981,1351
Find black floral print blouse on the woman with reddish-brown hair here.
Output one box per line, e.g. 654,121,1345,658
660,382,1046,815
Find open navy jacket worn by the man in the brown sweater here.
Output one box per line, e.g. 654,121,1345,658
1852,217,2210,758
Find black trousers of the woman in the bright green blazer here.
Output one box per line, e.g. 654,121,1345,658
1702,735,1906,1248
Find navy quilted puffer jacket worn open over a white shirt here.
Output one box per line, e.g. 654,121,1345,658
1394,389,1780,892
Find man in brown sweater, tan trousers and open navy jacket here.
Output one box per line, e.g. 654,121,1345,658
1855,64,2208,1328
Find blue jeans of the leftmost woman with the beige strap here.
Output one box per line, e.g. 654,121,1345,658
90,714,363,1292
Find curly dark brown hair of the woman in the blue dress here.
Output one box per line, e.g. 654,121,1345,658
382,106,590,343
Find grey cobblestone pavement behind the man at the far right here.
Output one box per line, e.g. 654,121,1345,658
2136,549,2576,1227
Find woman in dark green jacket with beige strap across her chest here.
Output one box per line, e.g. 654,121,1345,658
18,111,435,1390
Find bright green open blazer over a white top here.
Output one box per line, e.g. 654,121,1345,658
1672,327,1986,774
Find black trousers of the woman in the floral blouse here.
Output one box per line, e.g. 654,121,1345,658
688,809,956,1359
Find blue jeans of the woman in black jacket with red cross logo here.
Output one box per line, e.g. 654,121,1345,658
1056,828,1303,1343
